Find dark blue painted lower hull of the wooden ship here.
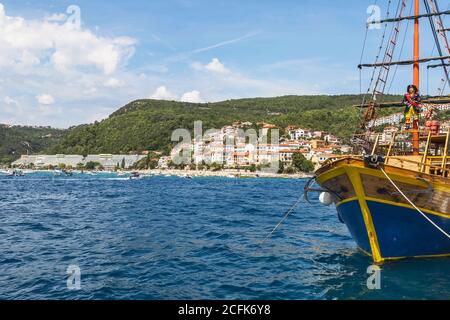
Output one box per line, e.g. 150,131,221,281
337,200,450,259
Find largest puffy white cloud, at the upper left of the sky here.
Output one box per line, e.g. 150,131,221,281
0,3,136,74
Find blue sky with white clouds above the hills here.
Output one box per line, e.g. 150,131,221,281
0,0,450,128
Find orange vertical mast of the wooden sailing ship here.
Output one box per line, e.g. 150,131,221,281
412,0,420,156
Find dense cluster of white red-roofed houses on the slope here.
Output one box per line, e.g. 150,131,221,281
158,122,351,170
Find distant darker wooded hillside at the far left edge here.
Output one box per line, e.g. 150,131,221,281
0,124,65,163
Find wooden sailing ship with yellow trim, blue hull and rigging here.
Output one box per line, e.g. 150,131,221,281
305,0,450,263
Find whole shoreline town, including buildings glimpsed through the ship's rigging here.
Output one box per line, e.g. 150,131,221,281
7,121,450,174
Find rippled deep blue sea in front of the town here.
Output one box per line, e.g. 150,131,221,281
0,174,450,300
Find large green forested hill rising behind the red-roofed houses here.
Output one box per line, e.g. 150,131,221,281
46,95,401,154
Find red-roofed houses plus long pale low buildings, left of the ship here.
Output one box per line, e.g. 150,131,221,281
4,122,344,171
